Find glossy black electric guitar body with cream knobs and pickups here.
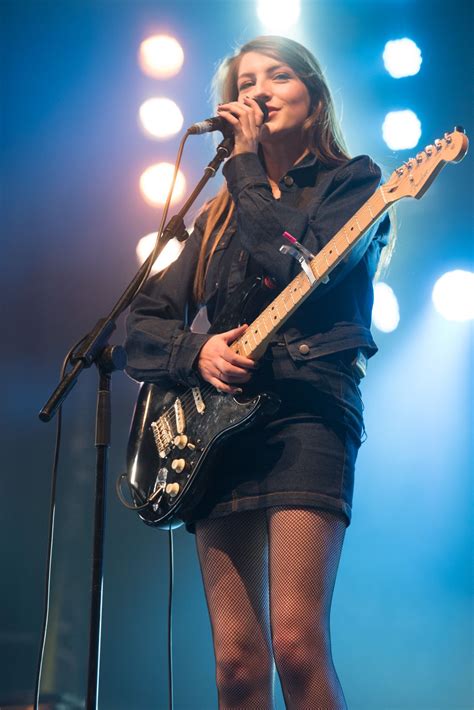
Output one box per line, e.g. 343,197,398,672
127,278,279,529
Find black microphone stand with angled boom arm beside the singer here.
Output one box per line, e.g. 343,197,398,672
38,131,233,710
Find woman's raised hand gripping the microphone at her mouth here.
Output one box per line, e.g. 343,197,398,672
217,96,264,155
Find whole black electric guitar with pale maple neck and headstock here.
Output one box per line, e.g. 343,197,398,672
125,129,468,529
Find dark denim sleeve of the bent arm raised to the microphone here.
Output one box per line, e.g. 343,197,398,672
224,153,388,298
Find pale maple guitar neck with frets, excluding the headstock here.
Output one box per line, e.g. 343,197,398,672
230,188,389,360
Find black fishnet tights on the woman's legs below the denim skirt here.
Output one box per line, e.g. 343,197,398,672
196,507,346,710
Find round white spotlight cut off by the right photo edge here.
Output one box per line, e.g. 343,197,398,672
431,269,474,321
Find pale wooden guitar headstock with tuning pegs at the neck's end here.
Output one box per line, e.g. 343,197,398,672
380,128,469,204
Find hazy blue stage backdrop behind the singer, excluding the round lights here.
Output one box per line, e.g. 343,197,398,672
0,0,473,710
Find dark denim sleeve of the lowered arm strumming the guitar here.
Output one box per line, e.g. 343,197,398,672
125,220,210,386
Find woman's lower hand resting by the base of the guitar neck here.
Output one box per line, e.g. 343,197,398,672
197,325,257,394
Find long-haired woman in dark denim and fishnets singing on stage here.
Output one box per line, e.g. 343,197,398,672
127,37,389,710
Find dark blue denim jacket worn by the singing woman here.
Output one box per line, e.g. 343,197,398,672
125,153,389,386
